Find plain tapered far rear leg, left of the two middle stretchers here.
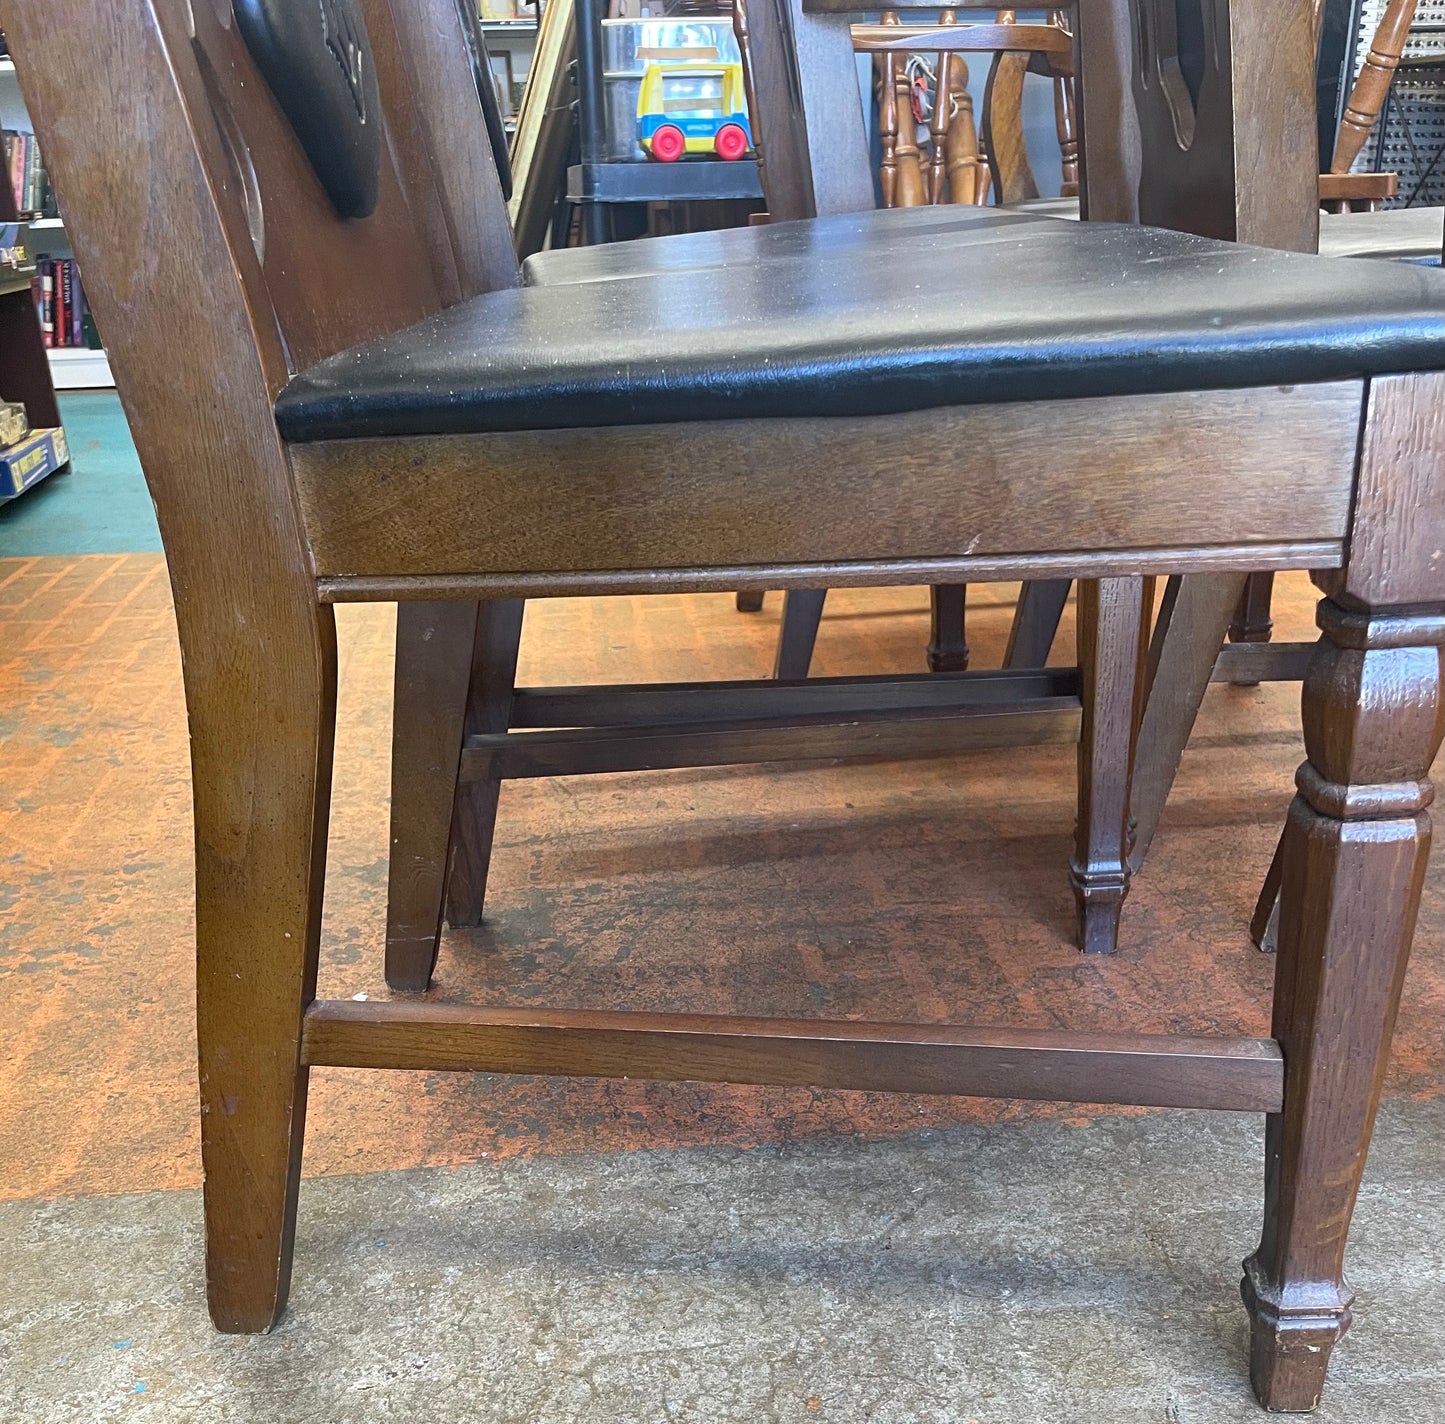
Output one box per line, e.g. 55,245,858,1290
386,601,478,990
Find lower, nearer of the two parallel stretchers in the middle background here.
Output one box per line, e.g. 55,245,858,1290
461,697,1079,781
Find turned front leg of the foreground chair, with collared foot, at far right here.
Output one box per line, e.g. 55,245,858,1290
1241,592,1445,1410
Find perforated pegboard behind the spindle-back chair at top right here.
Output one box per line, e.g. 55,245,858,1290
1350,0,1445,208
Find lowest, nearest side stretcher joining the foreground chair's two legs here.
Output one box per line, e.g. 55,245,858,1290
305,1000,1283,1112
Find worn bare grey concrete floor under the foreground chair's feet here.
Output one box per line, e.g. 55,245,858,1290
0,1100,1445,1424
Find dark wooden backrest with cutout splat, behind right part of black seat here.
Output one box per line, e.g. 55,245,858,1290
1075,0,1319,252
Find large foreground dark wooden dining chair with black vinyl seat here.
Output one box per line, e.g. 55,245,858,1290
14,0,1445,1408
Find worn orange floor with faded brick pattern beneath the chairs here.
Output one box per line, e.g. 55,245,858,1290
0,554,1445,1197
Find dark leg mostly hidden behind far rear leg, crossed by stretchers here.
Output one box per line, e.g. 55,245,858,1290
447,599,526,928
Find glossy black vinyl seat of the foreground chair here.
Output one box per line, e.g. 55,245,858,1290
276,208,1445,441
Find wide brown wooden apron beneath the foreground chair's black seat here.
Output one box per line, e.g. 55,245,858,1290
292,382,1361,584
